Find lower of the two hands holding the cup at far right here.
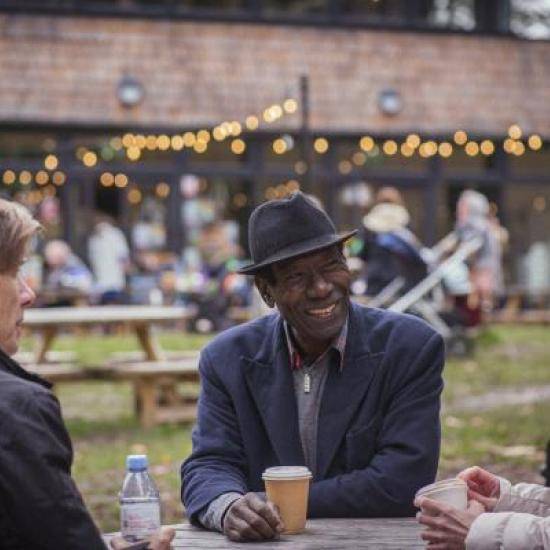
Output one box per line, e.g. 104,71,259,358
414,497,485,550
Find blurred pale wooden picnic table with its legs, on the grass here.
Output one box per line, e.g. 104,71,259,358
24,305,193,363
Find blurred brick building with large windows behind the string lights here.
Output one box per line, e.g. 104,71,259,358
0,0,550,288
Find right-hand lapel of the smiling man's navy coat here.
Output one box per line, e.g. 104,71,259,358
315,306,383,479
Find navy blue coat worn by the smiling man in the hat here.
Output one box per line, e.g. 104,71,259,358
181,304,444,524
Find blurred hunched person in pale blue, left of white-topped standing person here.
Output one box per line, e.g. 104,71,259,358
43,239,93,307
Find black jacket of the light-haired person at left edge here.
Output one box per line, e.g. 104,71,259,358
0,350,106,550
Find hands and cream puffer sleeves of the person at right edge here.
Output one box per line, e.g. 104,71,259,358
415,466,550,550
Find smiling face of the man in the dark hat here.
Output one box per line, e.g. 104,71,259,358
268,246,350,358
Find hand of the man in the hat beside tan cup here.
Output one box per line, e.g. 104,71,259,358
223,493,284,542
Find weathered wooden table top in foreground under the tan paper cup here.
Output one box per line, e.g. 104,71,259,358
105,518,425,550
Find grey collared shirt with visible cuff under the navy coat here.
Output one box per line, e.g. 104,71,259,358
199,319,348,531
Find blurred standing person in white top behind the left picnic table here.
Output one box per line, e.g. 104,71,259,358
88,213,130,305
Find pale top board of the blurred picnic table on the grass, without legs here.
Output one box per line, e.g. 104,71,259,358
24,305,193,327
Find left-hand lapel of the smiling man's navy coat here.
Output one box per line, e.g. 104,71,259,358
243,320,305,465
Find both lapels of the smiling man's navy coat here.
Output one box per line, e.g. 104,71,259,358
243,303,381,479
